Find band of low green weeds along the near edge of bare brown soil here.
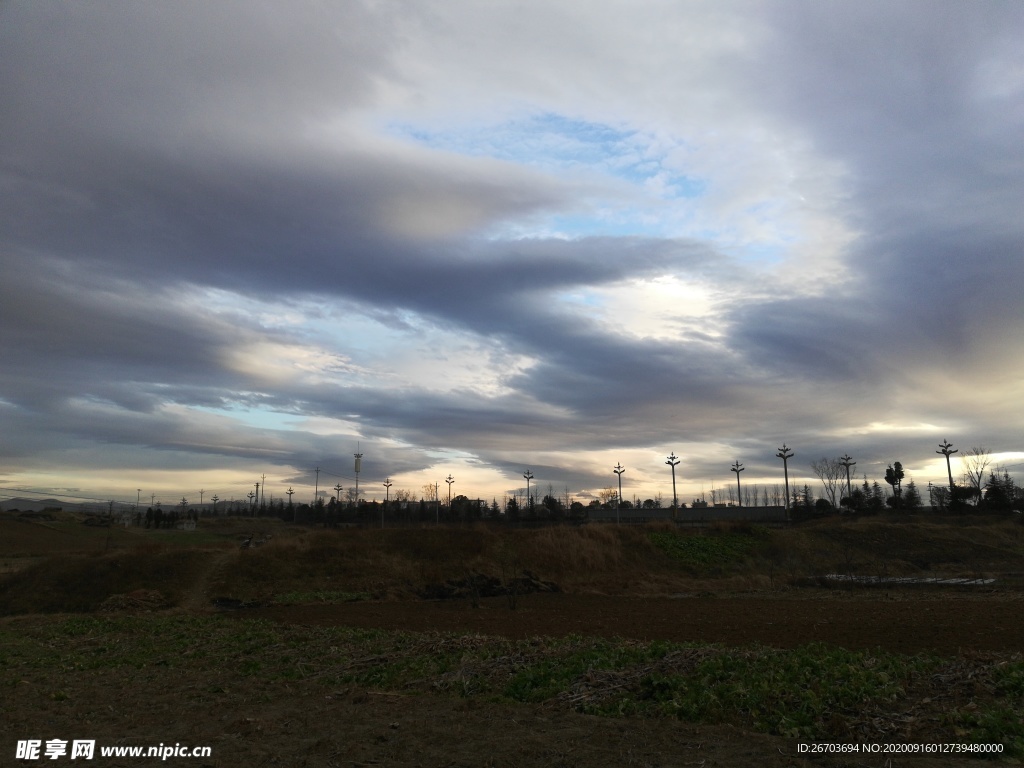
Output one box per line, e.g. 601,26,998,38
0,613,1024,758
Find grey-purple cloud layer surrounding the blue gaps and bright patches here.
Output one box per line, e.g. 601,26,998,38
0,2,1024,501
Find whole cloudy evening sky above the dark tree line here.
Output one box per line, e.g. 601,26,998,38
0,0,1024,512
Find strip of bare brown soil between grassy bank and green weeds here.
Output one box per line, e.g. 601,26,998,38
240,593,1024,653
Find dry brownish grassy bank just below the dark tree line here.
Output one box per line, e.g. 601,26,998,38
0,517,1024,613
